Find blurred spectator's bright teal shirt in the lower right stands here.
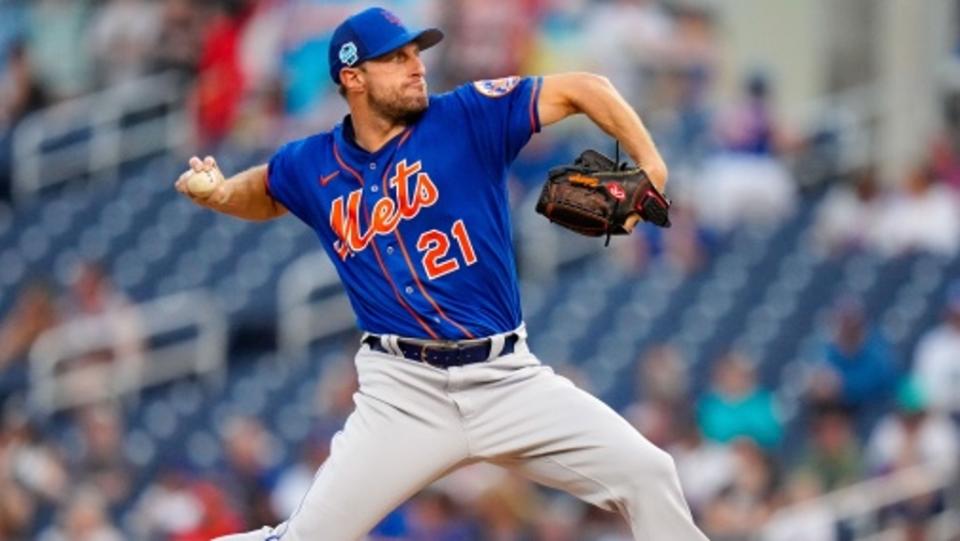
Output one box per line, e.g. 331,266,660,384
698,389,783,449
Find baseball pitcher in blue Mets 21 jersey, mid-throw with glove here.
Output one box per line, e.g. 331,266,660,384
176,8,706,541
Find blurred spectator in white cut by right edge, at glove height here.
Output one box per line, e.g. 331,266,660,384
871,165,960,256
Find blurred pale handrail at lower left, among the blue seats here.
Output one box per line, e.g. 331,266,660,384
29,290,228,414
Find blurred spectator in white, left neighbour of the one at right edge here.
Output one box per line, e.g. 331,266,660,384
813,169,883,254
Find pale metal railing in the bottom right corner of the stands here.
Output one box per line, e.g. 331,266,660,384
757,465,960,541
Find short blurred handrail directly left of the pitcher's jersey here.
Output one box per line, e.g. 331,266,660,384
277,251,356,357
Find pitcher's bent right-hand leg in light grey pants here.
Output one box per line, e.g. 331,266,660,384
481,371,705,541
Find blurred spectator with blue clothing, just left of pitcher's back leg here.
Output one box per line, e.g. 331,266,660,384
223,417,276,528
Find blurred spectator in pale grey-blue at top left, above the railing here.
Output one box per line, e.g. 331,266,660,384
27,0,92,100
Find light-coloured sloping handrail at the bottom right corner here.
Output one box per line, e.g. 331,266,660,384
759,465,960,539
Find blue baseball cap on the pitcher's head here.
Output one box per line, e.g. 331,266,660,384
330,7,443,85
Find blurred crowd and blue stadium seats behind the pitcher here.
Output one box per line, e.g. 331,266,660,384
0,0,960,541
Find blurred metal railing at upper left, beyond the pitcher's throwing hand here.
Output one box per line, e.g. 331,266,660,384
13,72,187,201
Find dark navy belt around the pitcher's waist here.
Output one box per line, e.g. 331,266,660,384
362,332,520,368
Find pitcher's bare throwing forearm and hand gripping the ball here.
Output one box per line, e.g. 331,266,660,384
177,157,287,221
